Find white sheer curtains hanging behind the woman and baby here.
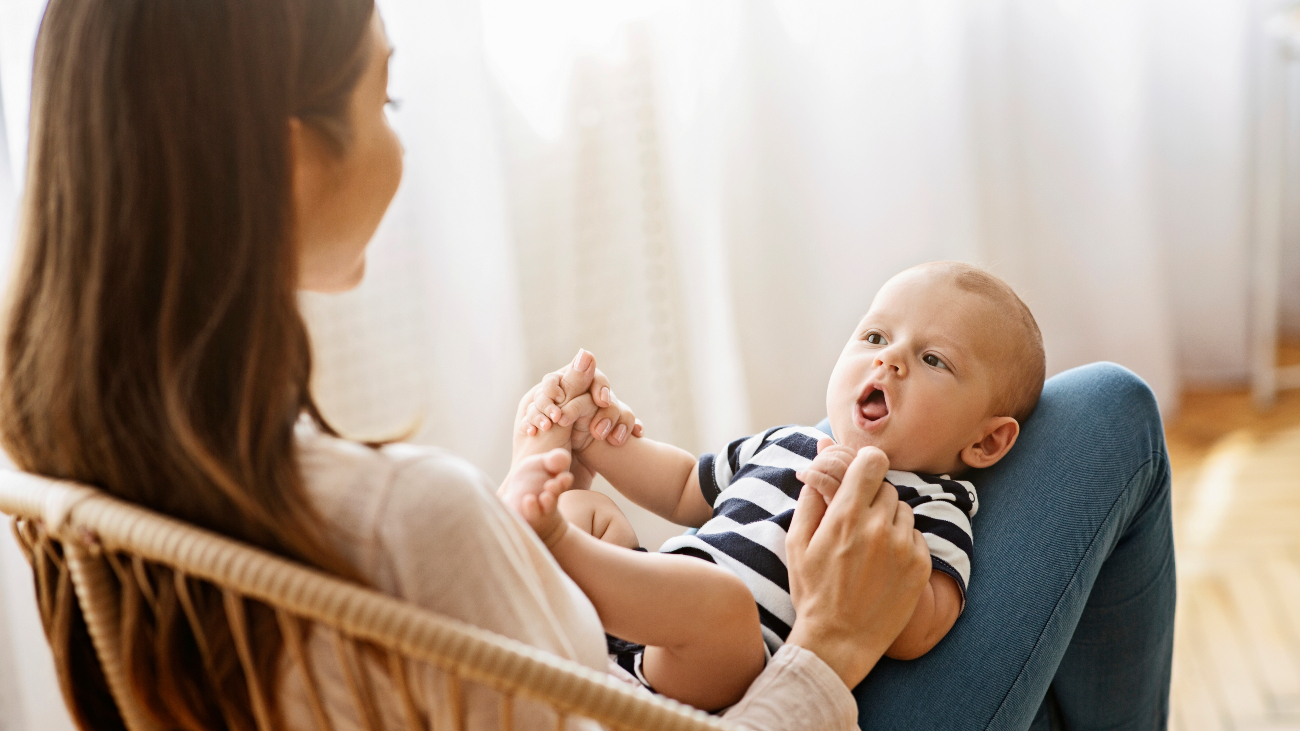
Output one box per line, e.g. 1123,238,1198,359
0,0,1300,731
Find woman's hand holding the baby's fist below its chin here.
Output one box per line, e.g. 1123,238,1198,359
785,446,930,688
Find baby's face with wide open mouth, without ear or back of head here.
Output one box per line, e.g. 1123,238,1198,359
826,269,997,473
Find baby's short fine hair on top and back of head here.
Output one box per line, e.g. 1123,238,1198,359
918,261,1047,424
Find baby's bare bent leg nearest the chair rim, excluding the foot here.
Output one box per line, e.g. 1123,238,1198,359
551,529,766,710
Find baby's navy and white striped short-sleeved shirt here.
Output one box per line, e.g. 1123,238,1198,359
659,427,979,653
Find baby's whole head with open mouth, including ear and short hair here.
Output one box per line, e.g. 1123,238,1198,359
826,261,1047,475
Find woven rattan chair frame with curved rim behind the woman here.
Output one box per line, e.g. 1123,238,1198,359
0,470,736,731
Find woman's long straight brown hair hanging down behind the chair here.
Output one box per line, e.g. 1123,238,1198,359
0,0,373,730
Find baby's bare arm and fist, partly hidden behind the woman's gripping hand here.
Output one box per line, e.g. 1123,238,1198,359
797,438,962,659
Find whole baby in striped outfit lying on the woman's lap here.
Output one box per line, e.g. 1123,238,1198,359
503,261,1045,709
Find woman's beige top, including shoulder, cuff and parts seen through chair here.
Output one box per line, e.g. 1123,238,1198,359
281,427,857,731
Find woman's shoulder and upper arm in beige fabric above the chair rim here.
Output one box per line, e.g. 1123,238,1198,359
299,421,606,669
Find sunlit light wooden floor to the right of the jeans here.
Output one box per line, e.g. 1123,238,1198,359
1166,351,1300,731
